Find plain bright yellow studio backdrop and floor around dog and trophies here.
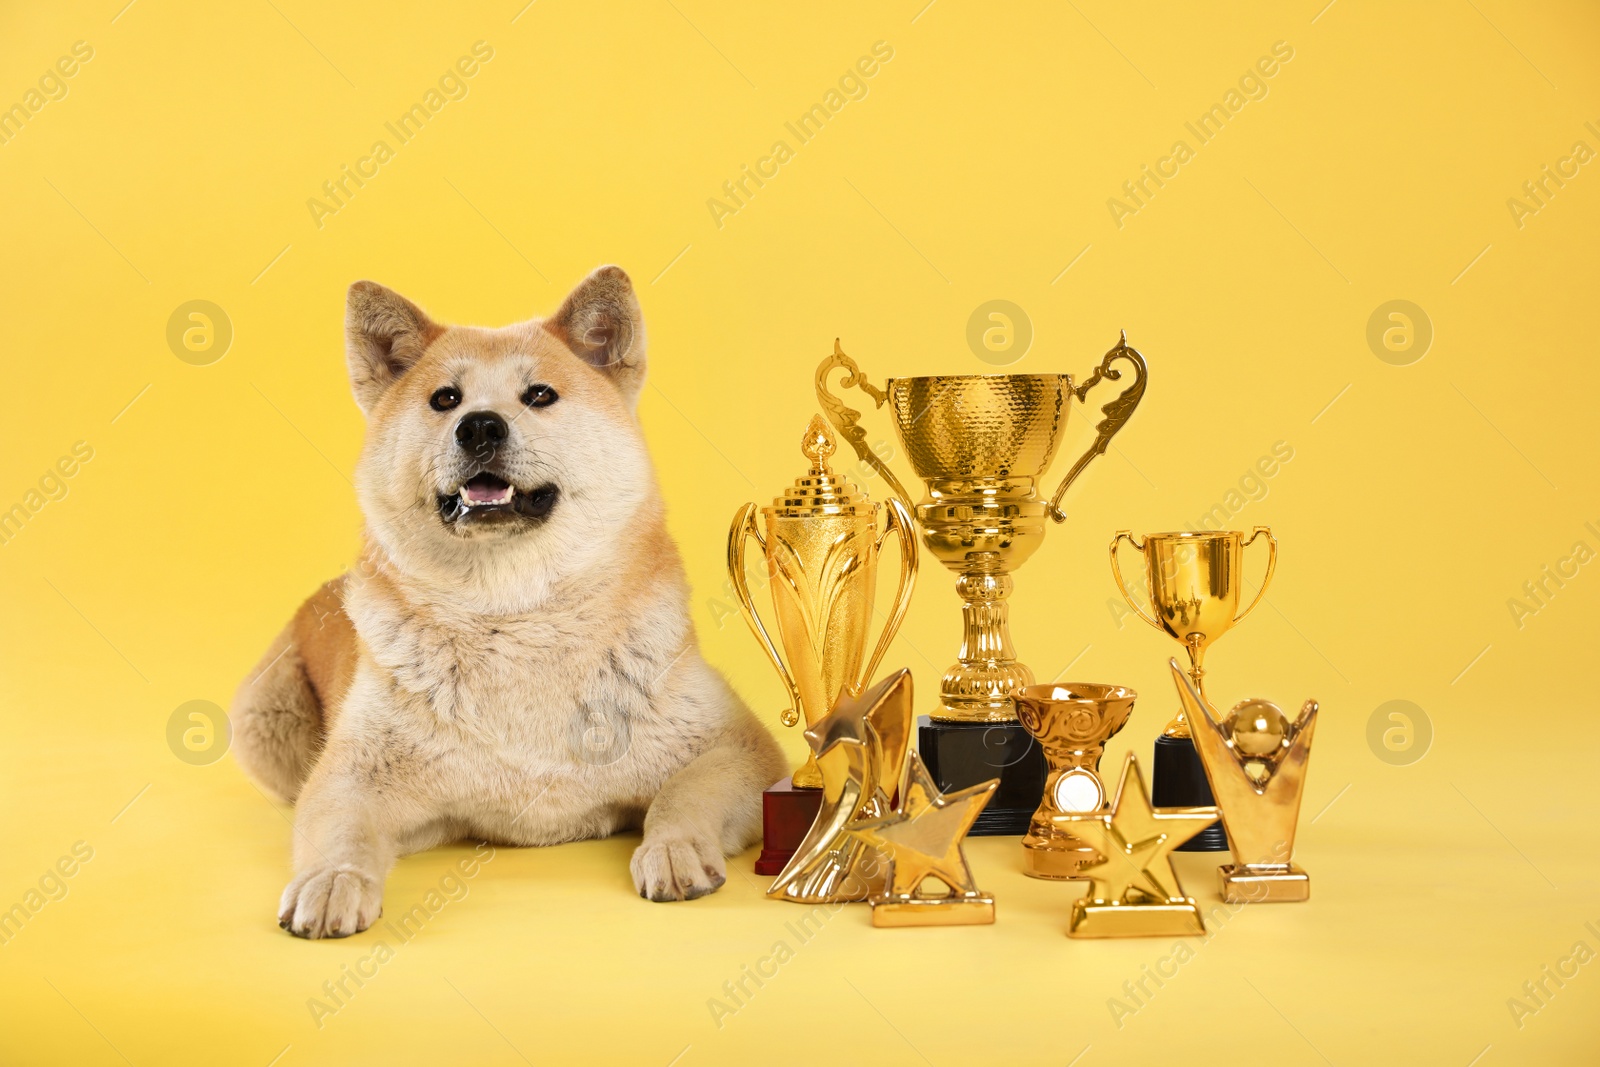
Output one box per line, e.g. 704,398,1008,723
0,0,1600,1067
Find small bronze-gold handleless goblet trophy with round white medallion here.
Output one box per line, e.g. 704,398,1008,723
1014,681,1139,878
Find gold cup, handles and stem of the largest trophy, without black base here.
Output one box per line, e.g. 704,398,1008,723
816,334,1147,721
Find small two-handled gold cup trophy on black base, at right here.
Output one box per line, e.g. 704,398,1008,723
1110,526,1278,853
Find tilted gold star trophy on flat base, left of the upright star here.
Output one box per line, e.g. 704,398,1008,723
848,749,1000,926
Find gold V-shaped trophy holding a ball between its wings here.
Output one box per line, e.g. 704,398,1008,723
1166,659,1317,904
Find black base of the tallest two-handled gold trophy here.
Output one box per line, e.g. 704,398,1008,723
917,715,1048,837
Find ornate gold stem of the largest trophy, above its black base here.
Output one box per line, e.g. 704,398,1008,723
933,552,1034,723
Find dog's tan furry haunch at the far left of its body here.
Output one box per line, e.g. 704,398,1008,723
230,579,355,801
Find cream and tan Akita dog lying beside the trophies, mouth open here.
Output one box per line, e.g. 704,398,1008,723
234,267,784,937
